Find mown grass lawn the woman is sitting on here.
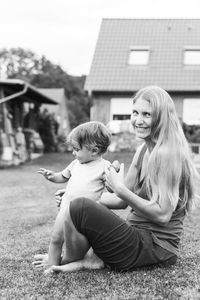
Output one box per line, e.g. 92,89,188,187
0,153,200,300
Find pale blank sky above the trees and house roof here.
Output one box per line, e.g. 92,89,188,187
0,0,200,76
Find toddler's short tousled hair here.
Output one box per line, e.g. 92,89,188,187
67,121,111,154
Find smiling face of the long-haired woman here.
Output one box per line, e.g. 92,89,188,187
131,97,152,140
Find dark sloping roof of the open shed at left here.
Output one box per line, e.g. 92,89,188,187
0,79,57,105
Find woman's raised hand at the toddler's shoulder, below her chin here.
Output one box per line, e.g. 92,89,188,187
105,163,124,194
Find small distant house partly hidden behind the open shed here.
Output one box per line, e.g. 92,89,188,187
38,88,70,136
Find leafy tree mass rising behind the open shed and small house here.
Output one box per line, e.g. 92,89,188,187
0,48,90,128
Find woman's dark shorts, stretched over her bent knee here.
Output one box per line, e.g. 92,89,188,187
70,198,177,271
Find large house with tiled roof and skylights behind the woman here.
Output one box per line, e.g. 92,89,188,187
85,19,200,125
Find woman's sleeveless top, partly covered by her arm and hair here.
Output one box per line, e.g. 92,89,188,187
127,145,185,255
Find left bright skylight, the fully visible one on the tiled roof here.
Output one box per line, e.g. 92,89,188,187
128,49,149,65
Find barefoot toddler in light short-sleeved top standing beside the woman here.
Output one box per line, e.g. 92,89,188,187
38,122,119,274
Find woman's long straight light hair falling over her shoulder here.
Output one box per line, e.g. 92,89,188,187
133,86,198,210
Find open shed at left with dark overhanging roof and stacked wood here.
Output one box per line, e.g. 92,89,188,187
0,79,57,167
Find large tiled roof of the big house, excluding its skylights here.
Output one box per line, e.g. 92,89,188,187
85,19,200,92
